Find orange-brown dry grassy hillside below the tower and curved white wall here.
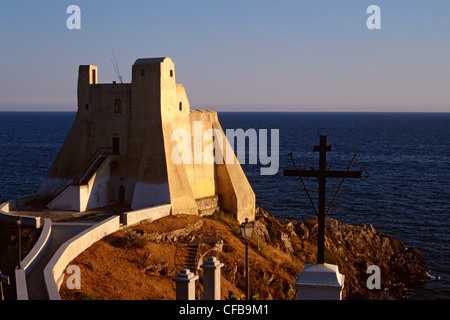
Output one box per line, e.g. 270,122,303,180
60,214,315,300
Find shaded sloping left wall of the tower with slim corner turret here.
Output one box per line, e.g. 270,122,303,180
38,74,132,196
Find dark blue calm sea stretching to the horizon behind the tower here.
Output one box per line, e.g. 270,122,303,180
0,112,450,299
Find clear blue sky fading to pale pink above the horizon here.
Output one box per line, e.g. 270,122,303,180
0,0,450,112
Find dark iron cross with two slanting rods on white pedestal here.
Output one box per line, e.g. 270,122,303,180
284,135,361,264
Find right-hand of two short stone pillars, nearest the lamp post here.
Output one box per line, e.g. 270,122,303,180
200,257,224,300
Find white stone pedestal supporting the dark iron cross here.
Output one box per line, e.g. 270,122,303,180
295,263,345,300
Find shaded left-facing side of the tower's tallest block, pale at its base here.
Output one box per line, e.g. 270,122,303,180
127,58,174,209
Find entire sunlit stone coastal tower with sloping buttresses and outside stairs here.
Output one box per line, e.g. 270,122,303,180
38,57,255,222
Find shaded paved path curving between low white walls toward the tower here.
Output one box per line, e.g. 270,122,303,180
27,220,99,300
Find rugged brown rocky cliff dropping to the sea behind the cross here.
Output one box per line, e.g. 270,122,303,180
257,208,427,299
